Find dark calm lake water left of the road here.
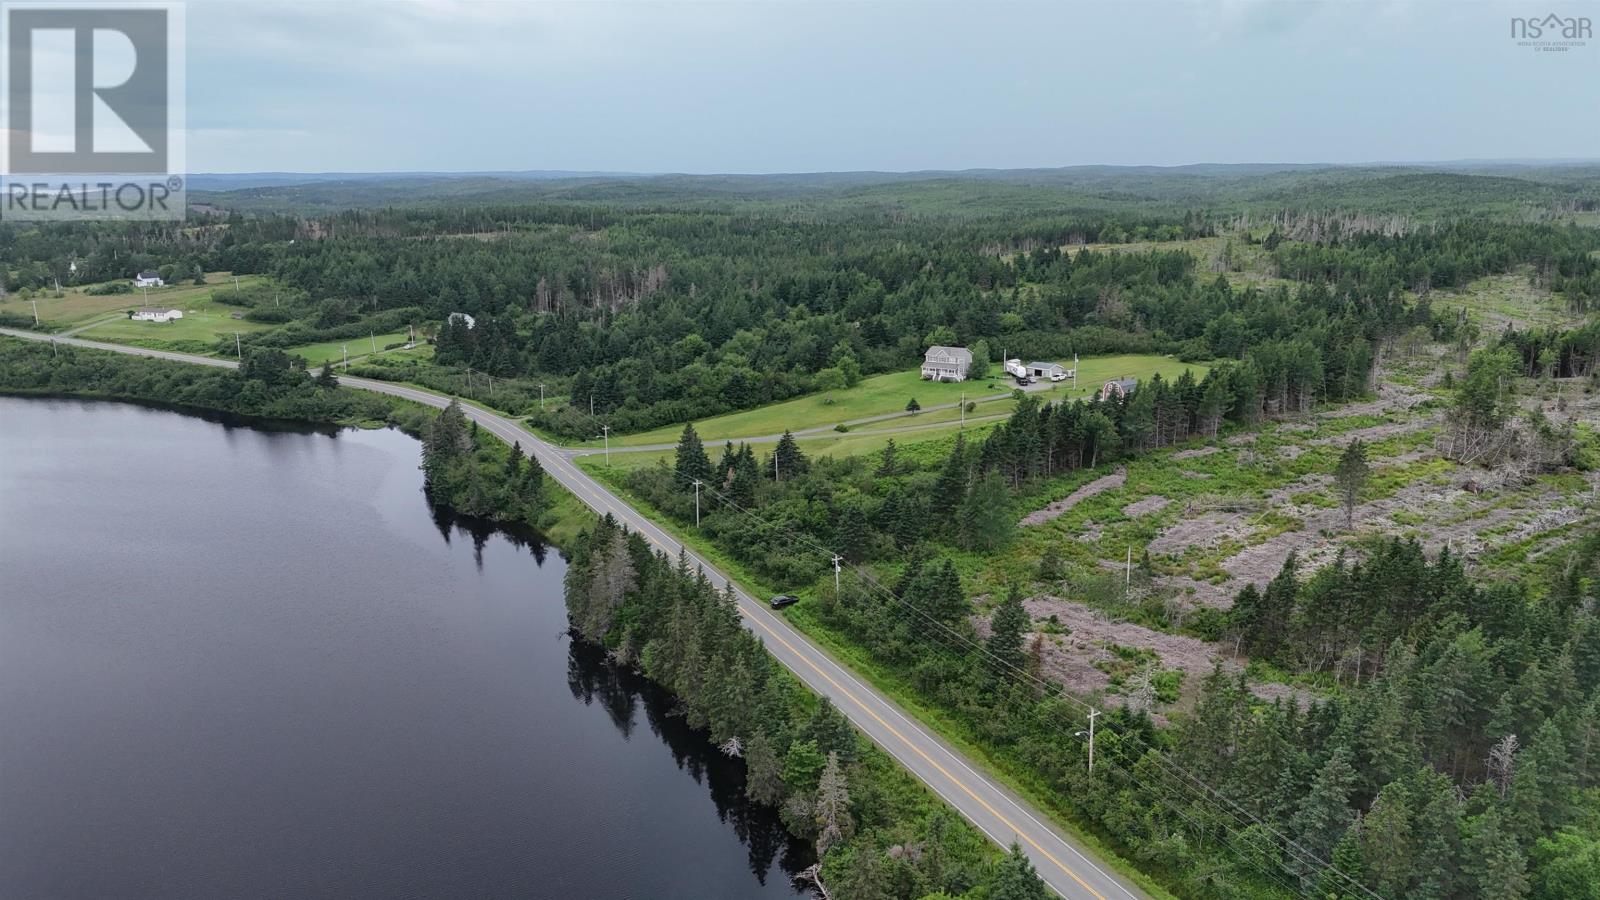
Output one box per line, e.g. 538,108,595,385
0,397,810,900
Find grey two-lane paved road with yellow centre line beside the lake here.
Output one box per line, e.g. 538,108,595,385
0,328,1144,900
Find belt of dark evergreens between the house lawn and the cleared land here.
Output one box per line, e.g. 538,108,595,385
626,350,1368,583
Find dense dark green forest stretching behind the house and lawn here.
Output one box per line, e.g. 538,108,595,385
15,203,1594,437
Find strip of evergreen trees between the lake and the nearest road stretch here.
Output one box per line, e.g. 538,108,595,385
565,516,1050,900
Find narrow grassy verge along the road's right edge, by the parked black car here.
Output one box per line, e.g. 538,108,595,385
569,460,1173,900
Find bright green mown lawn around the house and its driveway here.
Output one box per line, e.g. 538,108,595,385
581,354,1206,447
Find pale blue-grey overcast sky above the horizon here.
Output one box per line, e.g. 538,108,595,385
186,0,1600,173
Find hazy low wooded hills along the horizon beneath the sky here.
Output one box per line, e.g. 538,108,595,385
189,160,1600,218
